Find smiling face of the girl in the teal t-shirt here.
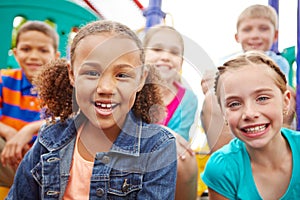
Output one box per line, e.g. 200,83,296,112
218,64,290,148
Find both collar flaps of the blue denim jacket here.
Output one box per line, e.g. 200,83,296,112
39,111,143,156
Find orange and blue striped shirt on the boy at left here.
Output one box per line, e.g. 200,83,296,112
0,69,41,130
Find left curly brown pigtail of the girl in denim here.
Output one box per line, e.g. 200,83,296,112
33,59,74,122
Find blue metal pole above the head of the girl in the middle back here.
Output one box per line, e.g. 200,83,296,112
143,0,166,30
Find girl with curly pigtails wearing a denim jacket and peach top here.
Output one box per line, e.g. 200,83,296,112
8,20,177,199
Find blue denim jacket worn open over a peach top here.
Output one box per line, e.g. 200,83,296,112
7,112,177,200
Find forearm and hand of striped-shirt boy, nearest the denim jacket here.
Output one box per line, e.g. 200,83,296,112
1,120,44,168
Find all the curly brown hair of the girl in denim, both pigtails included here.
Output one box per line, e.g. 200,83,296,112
34,20,165,123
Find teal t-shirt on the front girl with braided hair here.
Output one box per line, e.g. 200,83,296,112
201,128,300,200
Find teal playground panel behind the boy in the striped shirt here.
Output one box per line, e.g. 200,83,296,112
0,0,101,68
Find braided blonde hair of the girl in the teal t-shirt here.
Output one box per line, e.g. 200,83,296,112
215,50,287,105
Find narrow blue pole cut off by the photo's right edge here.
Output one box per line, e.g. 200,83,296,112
296,0,300,130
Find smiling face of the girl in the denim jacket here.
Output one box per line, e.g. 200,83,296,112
71,33,147,132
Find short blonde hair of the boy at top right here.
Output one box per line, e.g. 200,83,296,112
236,4,278,30
